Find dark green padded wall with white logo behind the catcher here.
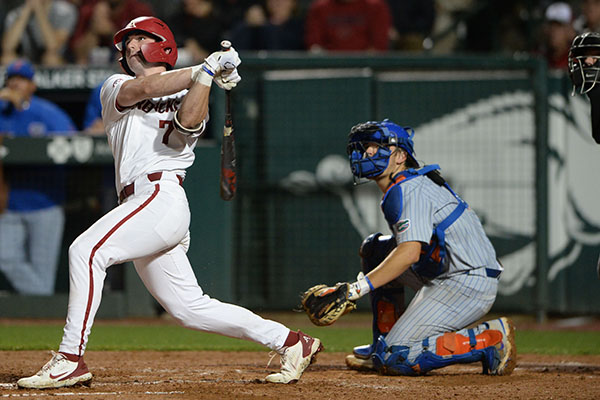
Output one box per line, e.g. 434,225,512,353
0,54,600,316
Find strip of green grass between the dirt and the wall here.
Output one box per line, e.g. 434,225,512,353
0,322,600,355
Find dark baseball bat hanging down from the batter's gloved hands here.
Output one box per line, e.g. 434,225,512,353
220,40,237,200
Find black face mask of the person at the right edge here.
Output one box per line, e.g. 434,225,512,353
569,32,600,94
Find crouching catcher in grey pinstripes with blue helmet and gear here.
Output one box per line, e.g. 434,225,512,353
302,120,516,375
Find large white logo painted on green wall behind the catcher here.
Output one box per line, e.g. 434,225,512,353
281,91,600,295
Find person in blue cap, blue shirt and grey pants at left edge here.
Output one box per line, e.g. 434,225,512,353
0,60,75,295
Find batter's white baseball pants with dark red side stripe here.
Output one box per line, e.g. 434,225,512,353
59,172,289,355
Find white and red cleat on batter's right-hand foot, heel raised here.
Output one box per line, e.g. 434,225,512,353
266,331,323,383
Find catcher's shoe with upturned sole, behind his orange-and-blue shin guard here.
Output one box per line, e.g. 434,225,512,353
483,317,517,375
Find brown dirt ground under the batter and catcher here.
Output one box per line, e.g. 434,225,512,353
0,351,600,400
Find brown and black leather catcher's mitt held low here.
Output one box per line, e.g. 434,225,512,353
300,283,356,326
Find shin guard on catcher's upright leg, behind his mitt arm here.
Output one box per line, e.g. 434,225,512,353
353,233,405,359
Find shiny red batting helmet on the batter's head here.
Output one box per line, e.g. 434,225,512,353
114,17,177,75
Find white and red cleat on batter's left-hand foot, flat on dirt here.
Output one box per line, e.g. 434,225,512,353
17,352,92,389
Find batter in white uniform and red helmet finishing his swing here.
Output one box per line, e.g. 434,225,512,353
18,17,322,389
